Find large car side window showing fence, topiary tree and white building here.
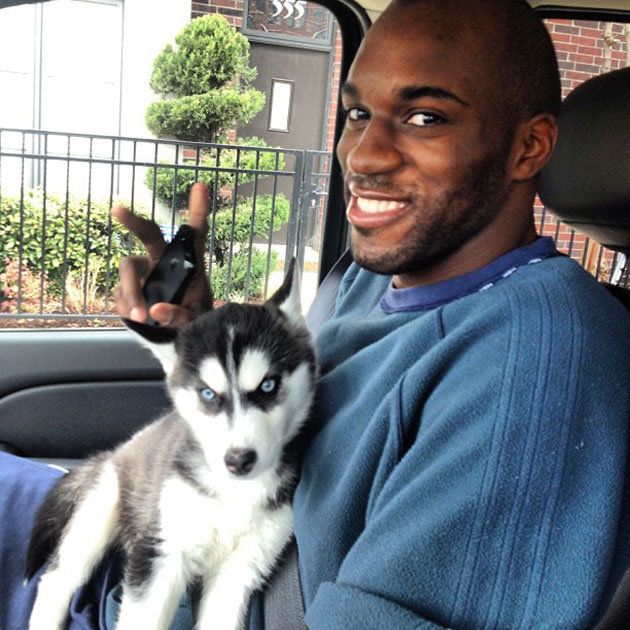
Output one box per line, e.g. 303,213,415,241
0,0,342,328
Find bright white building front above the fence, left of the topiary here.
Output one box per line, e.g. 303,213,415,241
0,0,123,196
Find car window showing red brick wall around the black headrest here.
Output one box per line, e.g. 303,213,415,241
536,18,630,288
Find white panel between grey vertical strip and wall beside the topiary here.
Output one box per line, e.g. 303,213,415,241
38,0,123,197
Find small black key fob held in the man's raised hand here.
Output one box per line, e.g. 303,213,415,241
142,225,197,325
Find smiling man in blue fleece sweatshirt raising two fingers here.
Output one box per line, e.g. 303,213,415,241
1,0,630,630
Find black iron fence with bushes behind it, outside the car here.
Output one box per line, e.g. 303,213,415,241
0,129,331,323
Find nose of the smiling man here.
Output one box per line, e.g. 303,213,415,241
346,119,403,175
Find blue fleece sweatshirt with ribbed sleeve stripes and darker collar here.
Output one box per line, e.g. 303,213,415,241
294,239,630,630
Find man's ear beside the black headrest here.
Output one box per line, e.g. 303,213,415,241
512,114,558,182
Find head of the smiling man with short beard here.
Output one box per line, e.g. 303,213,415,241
338,1,560,286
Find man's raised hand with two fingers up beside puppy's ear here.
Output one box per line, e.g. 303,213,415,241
112,182,212,326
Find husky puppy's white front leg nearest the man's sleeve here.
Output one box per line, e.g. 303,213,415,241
197,505,293,630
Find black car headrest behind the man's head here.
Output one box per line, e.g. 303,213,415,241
539,68,630,251
